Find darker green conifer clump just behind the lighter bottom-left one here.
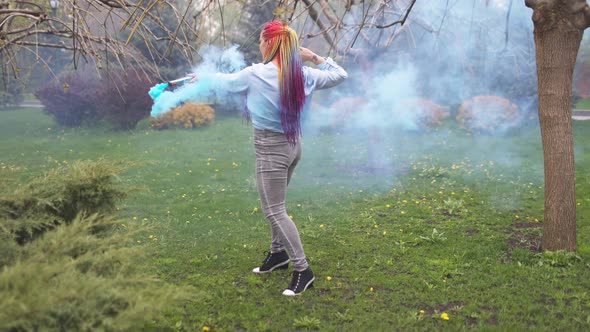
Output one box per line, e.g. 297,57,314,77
0,161,127,244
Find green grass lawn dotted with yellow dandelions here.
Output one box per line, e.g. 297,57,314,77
0,109,590,331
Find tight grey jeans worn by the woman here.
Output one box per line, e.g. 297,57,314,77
254,129,308,271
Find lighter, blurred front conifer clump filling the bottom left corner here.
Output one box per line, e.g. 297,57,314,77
0,215,188,331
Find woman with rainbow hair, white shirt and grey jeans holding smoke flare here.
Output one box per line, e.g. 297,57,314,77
193,20,348,296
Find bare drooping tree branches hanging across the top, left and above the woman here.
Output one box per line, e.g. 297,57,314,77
0,0,416,77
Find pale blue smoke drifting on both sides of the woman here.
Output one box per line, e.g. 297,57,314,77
152,0,542,192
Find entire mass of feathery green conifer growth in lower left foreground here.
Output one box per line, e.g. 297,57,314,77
0,161,192,331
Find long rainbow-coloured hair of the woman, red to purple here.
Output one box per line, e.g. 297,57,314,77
262,20,305,144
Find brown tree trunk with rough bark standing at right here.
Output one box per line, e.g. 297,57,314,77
526,0,588,251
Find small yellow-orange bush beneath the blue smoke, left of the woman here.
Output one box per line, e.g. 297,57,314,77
150,102,215,129
